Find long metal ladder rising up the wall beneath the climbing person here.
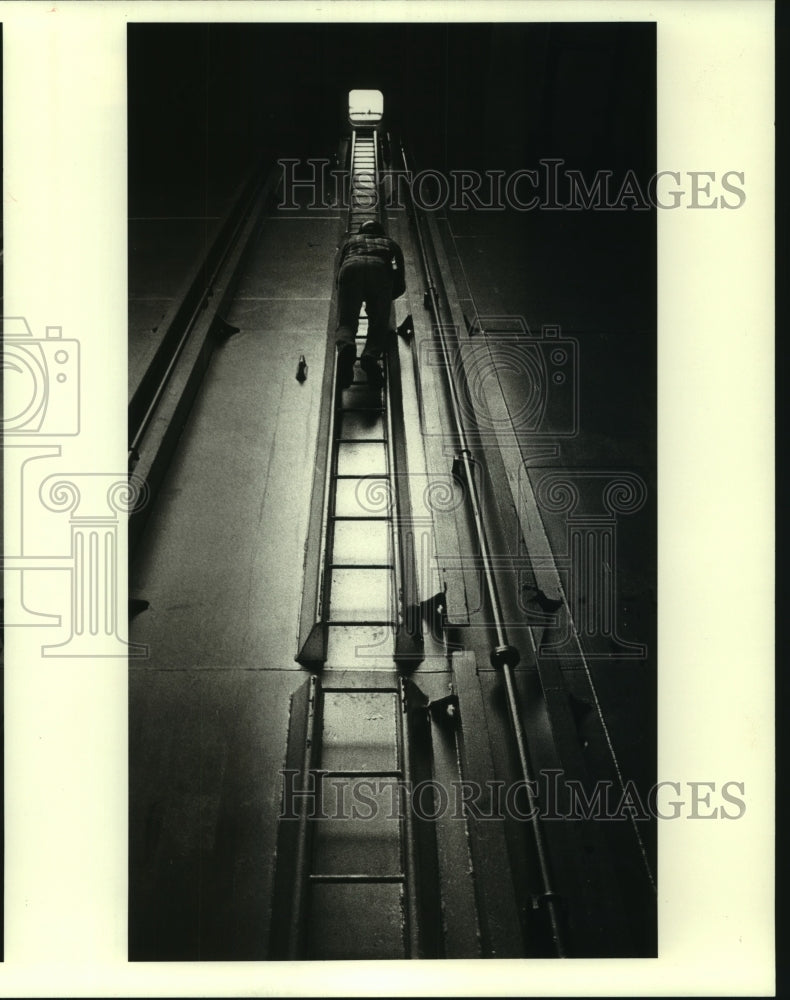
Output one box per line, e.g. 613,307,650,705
270,130,441,959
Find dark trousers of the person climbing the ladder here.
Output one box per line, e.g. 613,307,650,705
337,257,392,358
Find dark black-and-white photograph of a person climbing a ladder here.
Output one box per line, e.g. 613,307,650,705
128,23,664,961
